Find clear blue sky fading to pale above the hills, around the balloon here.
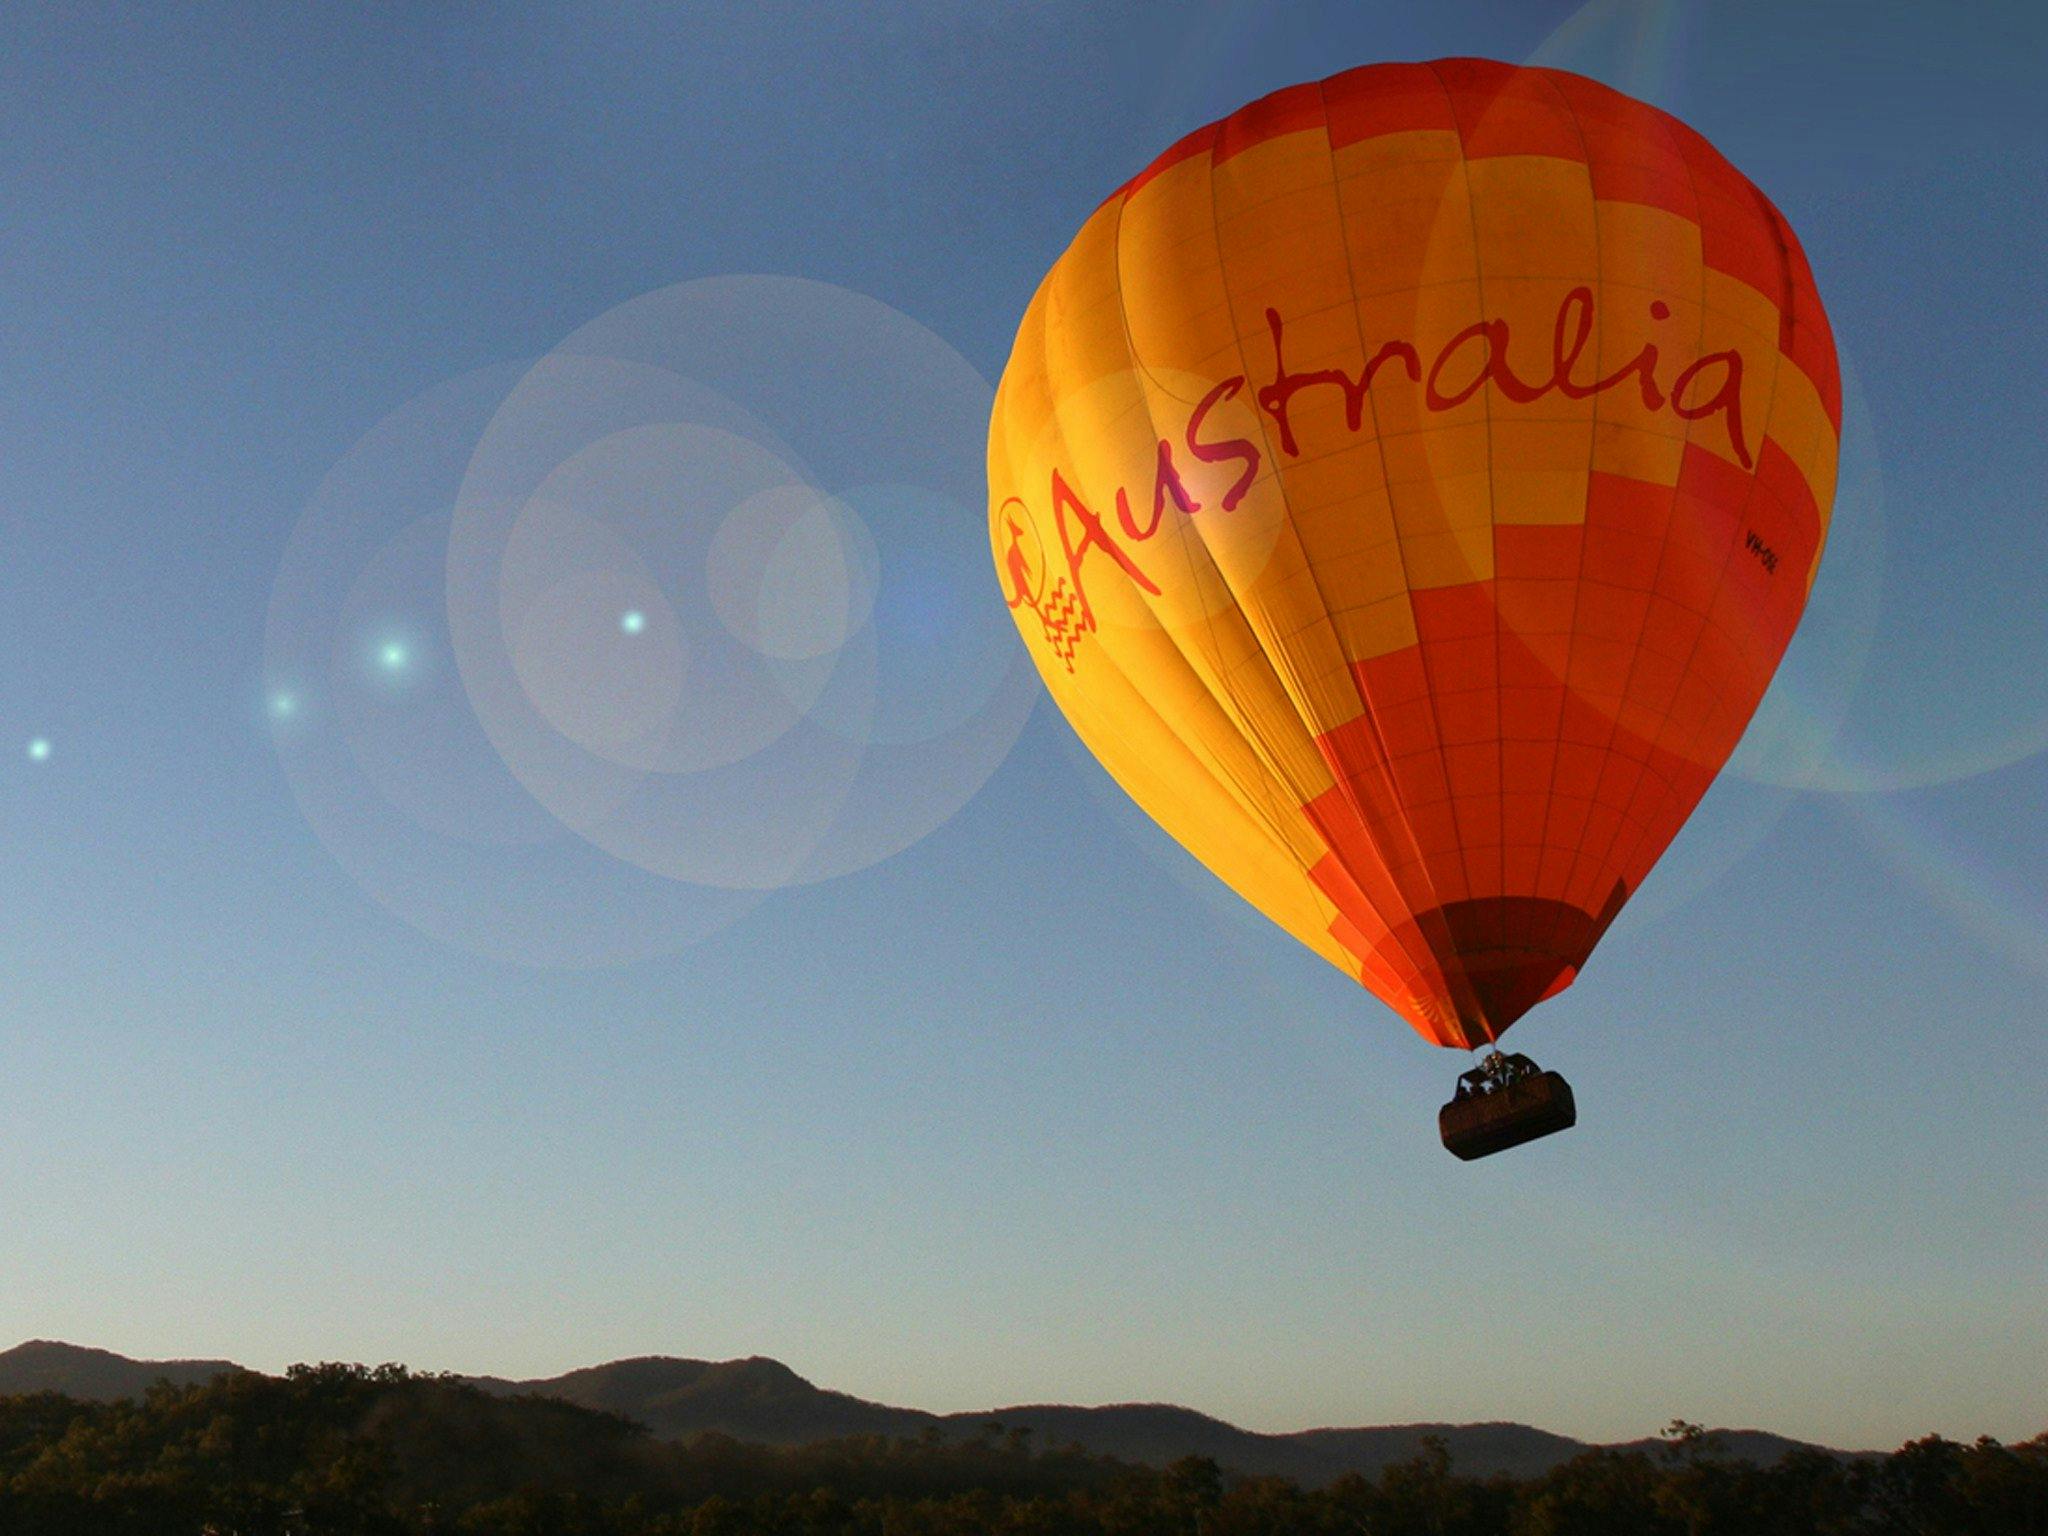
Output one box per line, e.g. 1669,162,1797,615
0,0,2048,1446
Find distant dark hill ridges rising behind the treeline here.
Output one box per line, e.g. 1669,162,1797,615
0,1339,1835,1487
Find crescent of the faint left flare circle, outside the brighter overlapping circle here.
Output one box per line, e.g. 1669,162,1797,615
264,369,756,967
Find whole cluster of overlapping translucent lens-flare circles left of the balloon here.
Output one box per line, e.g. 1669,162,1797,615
264,279,1034,965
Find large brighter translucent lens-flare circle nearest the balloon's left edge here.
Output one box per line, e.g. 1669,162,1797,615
449,279,1032,889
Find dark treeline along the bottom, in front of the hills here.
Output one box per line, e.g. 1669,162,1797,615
0,1366,2048,1536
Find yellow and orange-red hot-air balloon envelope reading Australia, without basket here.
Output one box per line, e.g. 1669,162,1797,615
989,59,1841,1047
